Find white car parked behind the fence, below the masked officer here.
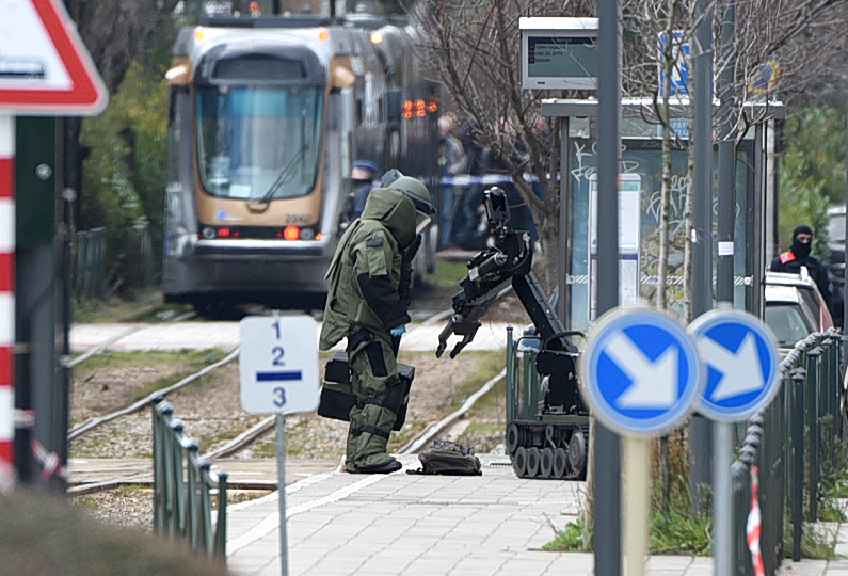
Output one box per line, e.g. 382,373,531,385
765,268,833,349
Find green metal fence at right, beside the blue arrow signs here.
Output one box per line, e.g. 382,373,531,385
731,330,846,576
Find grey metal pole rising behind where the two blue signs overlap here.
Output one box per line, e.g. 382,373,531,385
689,0,713,514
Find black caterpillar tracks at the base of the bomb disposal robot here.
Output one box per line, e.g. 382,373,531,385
506,418,589,480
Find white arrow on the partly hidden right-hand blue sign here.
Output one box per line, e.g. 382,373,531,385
698,332,766,401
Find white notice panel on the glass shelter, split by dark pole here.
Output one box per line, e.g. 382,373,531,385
589,174,642,321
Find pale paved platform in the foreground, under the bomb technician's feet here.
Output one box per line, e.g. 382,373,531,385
222,454,848,576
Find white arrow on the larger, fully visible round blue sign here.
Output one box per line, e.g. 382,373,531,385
604,333,677,409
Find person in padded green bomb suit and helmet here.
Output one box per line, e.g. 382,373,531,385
319,170,435,474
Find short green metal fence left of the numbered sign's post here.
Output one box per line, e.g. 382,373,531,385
151,398,227,563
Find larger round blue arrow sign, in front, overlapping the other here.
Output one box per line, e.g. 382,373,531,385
580,308,705,436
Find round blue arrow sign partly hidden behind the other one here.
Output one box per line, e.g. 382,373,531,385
689,309,780,421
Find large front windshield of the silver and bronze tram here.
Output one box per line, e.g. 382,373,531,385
197,85,322,202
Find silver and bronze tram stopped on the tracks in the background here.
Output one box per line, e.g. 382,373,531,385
162,17,438,317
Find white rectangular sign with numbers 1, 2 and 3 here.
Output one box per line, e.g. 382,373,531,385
239,316,320,414
